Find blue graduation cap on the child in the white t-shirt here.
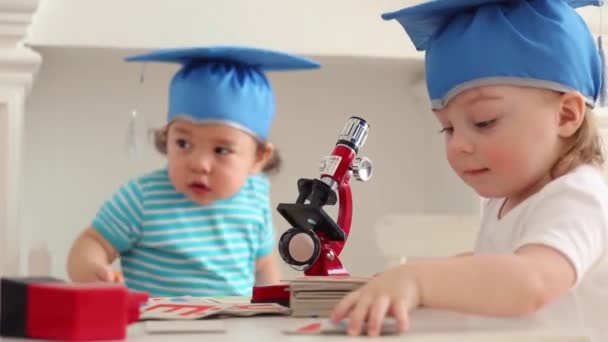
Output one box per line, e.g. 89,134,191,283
382,0,603,109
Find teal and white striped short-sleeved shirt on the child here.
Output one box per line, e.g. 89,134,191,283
93,169,274,297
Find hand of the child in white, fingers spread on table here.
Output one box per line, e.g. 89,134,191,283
331,265,420,336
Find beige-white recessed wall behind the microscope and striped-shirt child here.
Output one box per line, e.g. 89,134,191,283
21,48,477,277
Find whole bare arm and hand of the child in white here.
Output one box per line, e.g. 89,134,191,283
332,245,576,335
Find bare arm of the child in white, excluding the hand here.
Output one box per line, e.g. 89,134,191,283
411,245,576,316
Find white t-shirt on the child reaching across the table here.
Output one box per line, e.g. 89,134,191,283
475,165,608,342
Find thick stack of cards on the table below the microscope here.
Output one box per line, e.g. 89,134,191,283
289,276,370,317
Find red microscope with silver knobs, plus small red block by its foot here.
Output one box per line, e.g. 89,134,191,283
253,116,372,302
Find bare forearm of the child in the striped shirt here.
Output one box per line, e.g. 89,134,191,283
68,227,118,282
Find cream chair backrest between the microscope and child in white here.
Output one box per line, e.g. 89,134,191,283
374,214,479,266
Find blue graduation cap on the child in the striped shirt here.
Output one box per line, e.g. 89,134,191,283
126,46,320,141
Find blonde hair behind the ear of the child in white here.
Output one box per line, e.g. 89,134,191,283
551,107,604,178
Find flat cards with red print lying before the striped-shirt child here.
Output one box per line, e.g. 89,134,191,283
140,297,290,321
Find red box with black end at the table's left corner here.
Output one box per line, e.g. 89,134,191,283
0,278,148,341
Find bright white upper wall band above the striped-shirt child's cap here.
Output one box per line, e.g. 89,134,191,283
27,0,420,57
